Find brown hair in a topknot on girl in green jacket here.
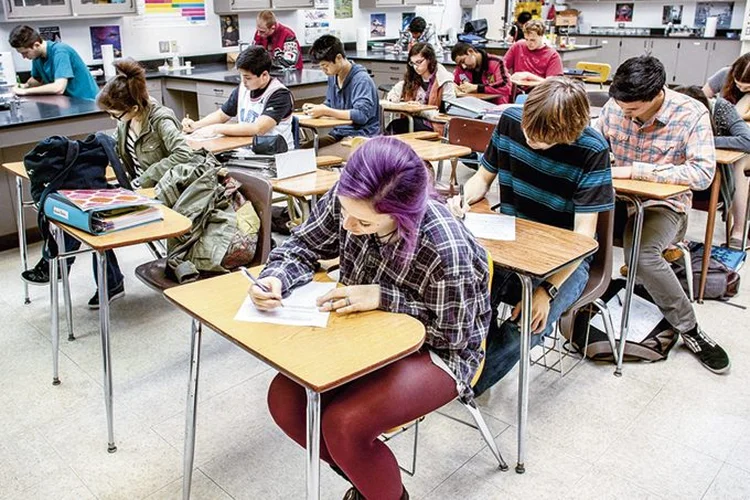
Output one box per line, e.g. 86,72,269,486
96,59,151,116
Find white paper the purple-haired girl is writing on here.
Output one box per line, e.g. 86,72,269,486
234,281,336,328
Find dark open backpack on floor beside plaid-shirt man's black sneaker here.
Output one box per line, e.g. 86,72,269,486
563,279,678,361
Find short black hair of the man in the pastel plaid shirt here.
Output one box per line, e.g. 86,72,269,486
609,56,667,102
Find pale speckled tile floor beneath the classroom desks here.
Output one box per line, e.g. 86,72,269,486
0,164,750,500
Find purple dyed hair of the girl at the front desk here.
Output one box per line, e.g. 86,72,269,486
338,137,433,253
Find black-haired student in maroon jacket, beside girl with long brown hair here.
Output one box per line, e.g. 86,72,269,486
451,42,511,104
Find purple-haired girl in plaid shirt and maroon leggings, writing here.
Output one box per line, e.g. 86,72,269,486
248,137,491,500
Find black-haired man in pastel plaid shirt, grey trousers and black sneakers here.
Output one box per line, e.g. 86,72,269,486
597,56,730,373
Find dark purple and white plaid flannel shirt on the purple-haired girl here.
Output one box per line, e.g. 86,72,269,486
261,186,491,400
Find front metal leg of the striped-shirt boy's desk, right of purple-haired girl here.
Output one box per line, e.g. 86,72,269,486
516,274,533,474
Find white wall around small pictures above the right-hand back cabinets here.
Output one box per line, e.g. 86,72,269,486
570,0,745,29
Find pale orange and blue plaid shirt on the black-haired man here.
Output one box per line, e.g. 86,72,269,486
597,89,716,212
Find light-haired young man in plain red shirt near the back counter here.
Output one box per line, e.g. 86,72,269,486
505,19,563,85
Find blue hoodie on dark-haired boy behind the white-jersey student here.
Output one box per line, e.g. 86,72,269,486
325,64,380,140
